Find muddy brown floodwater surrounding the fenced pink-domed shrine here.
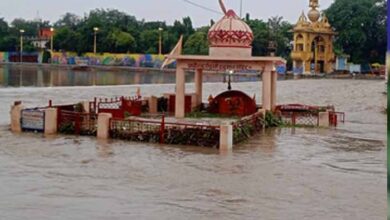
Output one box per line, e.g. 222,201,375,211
0,64,387,220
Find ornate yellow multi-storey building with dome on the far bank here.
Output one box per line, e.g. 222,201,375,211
291,0,336,74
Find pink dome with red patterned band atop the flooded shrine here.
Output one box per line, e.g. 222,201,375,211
208,10,253,48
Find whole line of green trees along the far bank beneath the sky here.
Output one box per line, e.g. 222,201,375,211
0,0,387,63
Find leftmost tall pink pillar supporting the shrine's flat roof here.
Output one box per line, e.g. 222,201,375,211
175,65,186,118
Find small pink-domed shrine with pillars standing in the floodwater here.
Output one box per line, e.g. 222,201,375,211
167,0,286,118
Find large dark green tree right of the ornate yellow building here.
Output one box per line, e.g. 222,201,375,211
325,0,387,63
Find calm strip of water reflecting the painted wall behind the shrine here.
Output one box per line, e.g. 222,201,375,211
0,65,259,87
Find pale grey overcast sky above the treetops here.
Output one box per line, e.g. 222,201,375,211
0,0,334,27
